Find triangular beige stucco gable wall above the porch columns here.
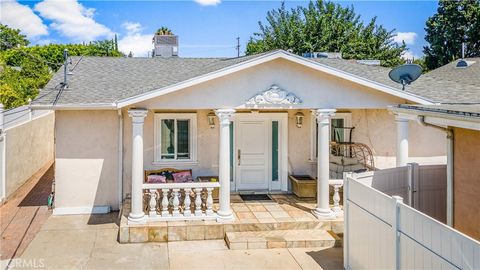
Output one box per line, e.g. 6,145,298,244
135,59,405,109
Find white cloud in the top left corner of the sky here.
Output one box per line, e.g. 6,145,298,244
0,0,48,38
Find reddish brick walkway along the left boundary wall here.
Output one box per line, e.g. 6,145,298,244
0,164,53,265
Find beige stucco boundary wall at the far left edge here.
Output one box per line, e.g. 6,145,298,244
0,112,55,203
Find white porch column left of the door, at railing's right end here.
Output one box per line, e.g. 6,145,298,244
215,109,235,220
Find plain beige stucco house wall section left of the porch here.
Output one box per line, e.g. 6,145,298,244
55,111,119,209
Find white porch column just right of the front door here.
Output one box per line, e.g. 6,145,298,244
313,109,336,219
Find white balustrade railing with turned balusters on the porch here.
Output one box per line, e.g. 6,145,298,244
142,182,220,221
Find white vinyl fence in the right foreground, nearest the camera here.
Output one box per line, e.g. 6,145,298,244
344,172,480,269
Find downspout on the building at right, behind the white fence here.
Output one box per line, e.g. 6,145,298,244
417,115,454,227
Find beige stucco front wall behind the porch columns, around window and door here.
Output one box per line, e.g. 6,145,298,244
123,109,446,193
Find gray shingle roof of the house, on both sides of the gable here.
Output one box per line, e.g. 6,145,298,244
33,52,480,106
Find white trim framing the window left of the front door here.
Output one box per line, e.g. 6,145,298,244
153,113,198,165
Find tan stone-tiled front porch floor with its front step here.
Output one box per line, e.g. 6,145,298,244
119,193,343,246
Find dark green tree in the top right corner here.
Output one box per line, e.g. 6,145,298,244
423,0,480,69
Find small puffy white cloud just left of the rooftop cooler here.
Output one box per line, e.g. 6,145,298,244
118,22,153,57
